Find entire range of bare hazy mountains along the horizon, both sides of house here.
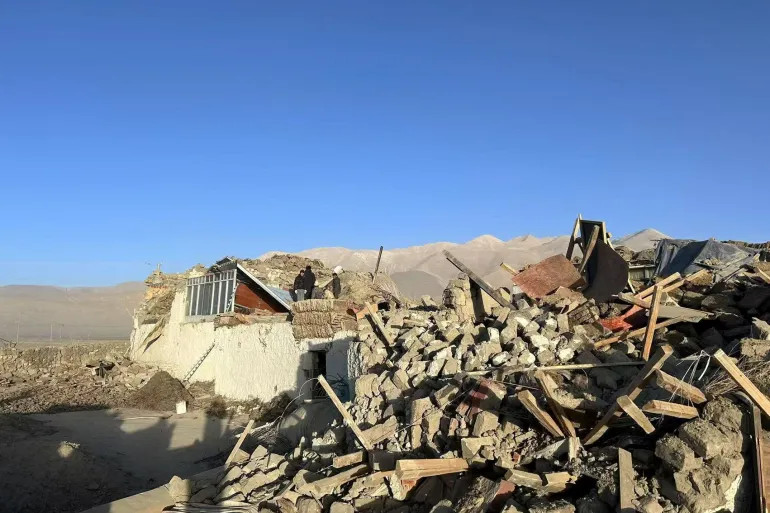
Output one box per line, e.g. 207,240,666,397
0,229,668,340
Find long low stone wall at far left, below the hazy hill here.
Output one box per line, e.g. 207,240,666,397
0,342,128,376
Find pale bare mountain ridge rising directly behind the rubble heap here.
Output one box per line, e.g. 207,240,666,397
261,228,668,298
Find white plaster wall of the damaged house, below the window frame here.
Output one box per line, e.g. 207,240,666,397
131,292,356,401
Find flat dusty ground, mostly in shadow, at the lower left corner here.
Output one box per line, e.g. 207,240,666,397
0,409,246,513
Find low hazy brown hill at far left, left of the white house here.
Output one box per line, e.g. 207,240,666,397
0,282,145,341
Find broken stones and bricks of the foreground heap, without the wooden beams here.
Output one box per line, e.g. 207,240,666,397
170,256,770,513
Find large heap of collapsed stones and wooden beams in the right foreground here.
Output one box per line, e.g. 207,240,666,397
170,256,770,513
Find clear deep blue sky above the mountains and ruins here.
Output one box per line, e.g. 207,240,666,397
0,0,770,286
